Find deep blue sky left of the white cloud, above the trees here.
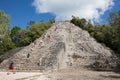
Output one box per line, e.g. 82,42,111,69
0,0,54,28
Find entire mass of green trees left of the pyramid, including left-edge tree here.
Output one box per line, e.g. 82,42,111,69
0,11,55,55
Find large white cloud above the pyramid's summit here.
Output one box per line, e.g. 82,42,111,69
33,0,114,20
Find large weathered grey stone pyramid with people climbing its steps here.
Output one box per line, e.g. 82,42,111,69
0,21,116,70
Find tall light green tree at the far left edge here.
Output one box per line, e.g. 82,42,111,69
0,11,15,55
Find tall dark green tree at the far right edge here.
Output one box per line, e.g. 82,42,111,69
109,10,120,53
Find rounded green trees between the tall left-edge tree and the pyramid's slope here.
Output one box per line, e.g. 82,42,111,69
11,21,52,47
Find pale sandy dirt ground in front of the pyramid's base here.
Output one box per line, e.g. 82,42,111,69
0,70,120,80
